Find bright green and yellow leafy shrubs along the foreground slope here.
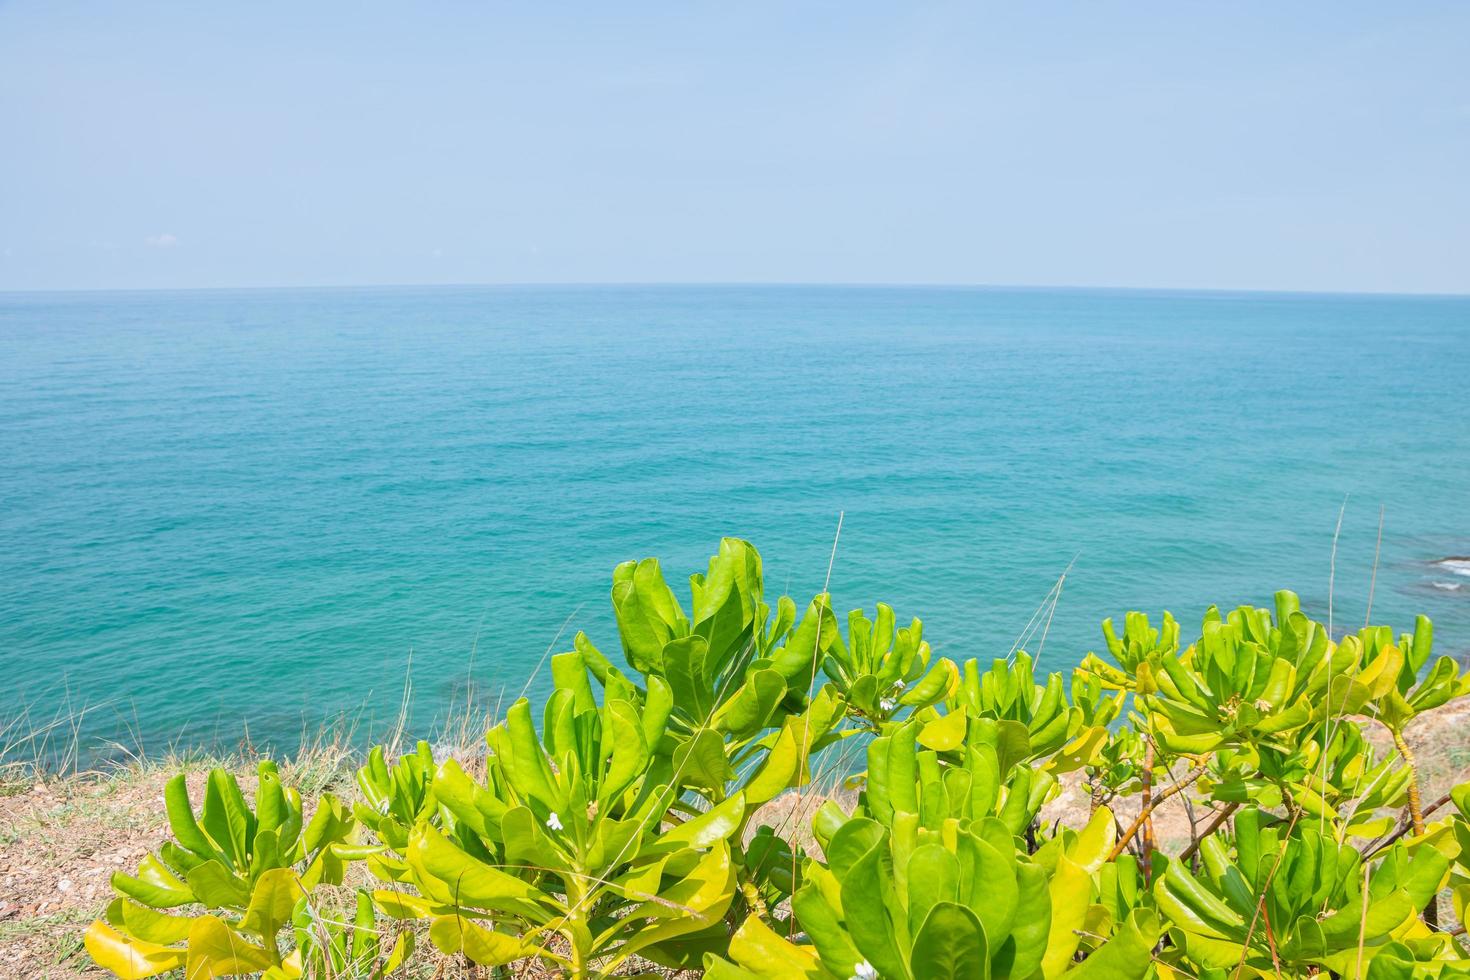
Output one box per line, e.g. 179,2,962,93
85,539,1470,980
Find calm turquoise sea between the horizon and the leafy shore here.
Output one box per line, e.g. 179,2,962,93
0,287,1470,749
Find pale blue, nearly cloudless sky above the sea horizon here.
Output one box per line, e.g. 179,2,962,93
0,0,1470,292
